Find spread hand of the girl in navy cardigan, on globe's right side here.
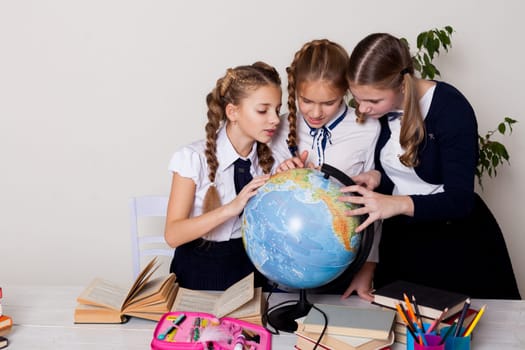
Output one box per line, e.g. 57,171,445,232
339,185,414,232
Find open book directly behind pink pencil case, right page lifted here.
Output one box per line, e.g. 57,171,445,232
171,273,264,324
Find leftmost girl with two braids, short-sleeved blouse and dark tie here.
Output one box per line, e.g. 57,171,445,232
165,62,281,290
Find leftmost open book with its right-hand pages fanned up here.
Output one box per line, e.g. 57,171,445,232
74,258,177,323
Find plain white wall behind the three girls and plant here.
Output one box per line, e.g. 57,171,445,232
0,0,525,294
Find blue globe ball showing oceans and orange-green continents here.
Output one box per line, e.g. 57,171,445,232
241,168,361,289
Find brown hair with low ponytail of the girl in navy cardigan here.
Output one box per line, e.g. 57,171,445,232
348,33,425,167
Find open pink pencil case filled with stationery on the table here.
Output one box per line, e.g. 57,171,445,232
151,311,272,350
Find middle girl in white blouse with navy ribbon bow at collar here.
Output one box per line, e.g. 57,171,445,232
271,39,380,300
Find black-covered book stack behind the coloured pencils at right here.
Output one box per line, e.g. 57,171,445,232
373,281,477,343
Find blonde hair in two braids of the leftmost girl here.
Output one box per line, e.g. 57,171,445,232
203,62,281,213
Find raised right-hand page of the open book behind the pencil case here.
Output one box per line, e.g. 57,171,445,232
213,272,254,317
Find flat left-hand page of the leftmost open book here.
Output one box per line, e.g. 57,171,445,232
77,278,128,311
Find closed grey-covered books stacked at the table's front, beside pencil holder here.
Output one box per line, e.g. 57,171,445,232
295,304,395,350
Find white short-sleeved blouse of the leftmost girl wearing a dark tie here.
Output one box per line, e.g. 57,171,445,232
169,126,263,241
